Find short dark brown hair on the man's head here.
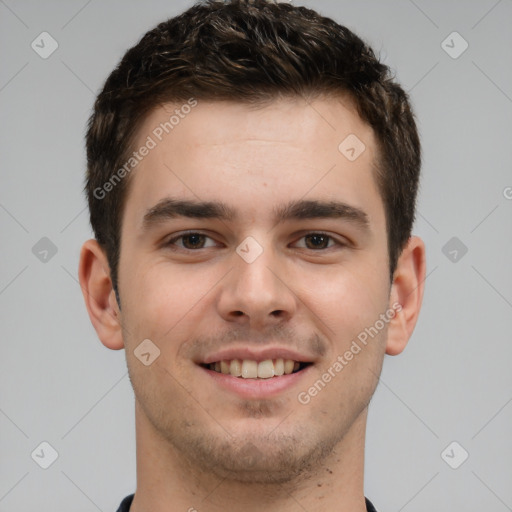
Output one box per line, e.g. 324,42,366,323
85,0,421,300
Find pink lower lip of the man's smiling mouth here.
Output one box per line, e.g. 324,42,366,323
199,365,313,400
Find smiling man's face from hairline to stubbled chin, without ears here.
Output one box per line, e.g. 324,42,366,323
119,98,394,482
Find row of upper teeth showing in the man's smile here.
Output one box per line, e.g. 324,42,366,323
209,359,300,379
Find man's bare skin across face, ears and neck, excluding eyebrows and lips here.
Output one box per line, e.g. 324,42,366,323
79,98,425,512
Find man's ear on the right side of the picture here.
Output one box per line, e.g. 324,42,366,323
386,236,426,356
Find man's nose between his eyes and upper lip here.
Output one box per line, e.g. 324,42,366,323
217,243,298,330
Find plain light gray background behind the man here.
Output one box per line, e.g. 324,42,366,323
0,0,512,512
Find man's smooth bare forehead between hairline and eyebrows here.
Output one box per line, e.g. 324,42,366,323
122,97,382,230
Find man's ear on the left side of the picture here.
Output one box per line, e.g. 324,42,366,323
78,240,124,350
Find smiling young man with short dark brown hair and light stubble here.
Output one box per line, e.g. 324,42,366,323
79,0,425,512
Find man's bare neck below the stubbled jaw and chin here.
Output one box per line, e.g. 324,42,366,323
130,401,367,512
